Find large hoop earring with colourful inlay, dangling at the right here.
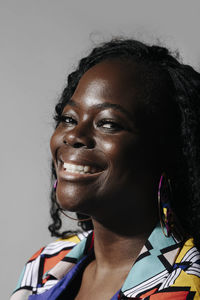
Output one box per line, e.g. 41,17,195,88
158,173,174,237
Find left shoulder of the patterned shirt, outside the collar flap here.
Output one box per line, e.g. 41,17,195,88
11,232,89,300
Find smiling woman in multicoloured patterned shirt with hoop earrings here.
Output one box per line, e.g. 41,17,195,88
11,39,200,300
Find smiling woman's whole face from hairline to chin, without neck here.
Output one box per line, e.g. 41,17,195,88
50,60,166,224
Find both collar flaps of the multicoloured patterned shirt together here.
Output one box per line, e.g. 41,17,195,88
45,224,182,297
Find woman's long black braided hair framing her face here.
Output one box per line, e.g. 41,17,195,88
49,39,200,249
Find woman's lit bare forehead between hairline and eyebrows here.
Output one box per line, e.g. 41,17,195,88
72,60,145,109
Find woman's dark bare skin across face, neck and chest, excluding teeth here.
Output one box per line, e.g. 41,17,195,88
51,59,175,300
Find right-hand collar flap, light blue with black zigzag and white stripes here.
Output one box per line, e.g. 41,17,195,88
121,224,182,296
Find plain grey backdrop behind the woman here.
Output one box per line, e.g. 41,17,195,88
0,0,200,299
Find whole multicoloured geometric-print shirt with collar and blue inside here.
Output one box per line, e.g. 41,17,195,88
11,225,200,300
